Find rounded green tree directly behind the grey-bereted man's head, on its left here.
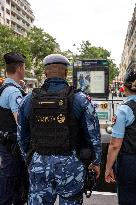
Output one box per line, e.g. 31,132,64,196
27,27,60,80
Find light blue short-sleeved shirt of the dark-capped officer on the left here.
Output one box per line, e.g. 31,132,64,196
0,78,23,112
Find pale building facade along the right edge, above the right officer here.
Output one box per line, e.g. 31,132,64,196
119,5,136,80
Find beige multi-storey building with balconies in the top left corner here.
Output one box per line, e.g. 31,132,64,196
0,0,35,35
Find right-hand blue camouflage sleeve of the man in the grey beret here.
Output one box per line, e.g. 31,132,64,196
75,92,102,165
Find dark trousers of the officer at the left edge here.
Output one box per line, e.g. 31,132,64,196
0,145,25,205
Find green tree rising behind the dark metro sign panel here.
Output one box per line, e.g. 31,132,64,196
78,41,119,82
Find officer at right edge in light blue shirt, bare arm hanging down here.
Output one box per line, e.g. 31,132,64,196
105,63,136,205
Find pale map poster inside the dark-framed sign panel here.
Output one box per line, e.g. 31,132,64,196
77,71,105,93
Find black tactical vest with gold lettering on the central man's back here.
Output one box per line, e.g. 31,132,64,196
30,87,81,154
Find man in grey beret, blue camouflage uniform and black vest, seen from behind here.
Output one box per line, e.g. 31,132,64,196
19,54,101,205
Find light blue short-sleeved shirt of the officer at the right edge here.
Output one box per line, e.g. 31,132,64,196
112,95,136,138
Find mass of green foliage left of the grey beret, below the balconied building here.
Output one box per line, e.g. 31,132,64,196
0,25,60,77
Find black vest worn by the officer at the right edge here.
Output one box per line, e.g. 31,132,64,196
121,100,136,154
